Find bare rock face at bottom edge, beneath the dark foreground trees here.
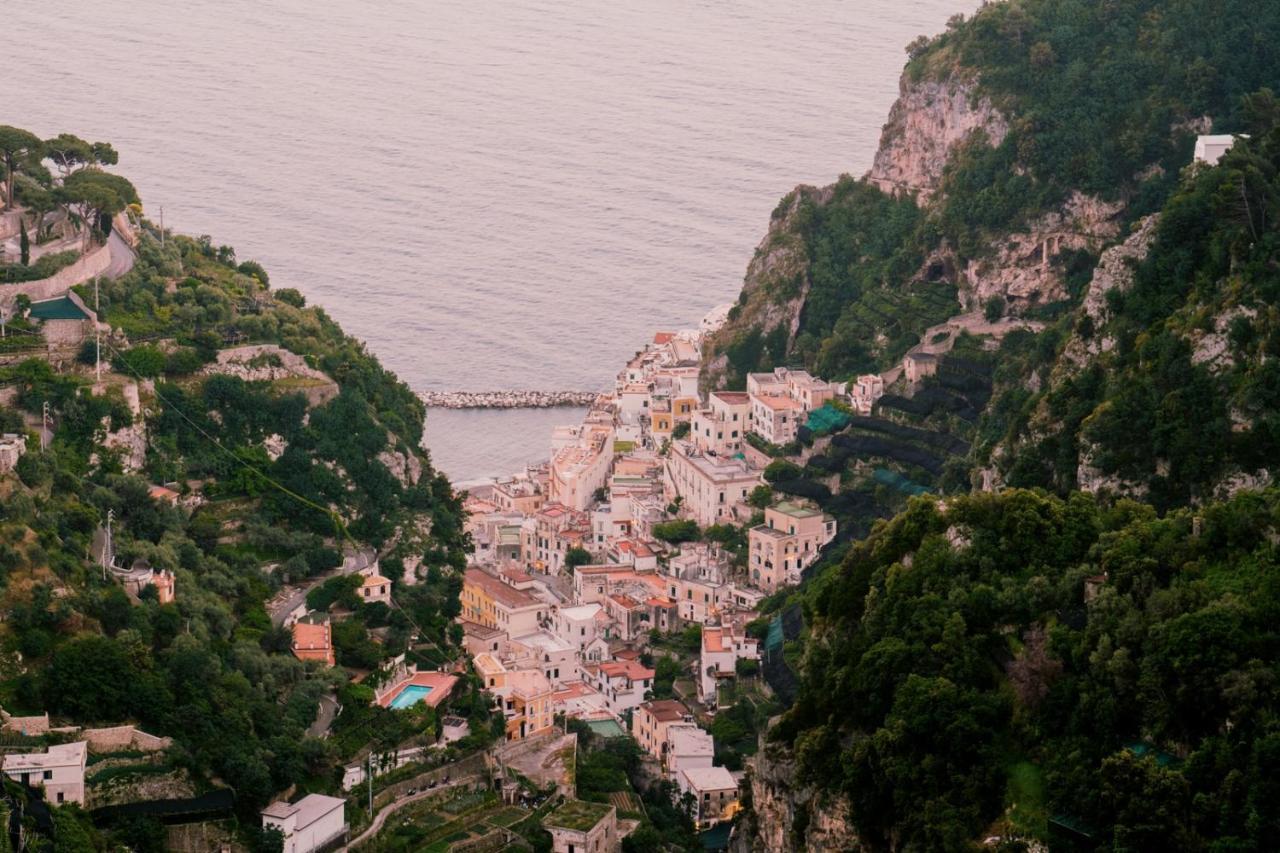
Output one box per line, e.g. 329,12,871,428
733,736,867,853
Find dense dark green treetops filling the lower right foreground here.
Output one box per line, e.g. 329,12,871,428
772,491,1280,849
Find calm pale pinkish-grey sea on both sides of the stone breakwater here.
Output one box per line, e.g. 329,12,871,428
0,0,977,479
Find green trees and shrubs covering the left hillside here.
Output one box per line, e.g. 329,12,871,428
0,144,492,849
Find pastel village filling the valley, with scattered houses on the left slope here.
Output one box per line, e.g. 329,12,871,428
0,89,1269,852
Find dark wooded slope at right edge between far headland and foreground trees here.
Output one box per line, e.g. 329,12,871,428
987,122,1280,508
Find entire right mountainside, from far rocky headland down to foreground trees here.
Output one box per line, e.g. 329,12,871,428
737,0,1280,850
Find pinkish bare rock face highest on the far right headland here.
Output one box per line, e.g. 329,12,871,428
867,74,1009,204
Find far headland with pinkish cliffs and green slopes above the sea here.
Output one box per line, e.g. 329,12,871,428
707,0,1280,386
